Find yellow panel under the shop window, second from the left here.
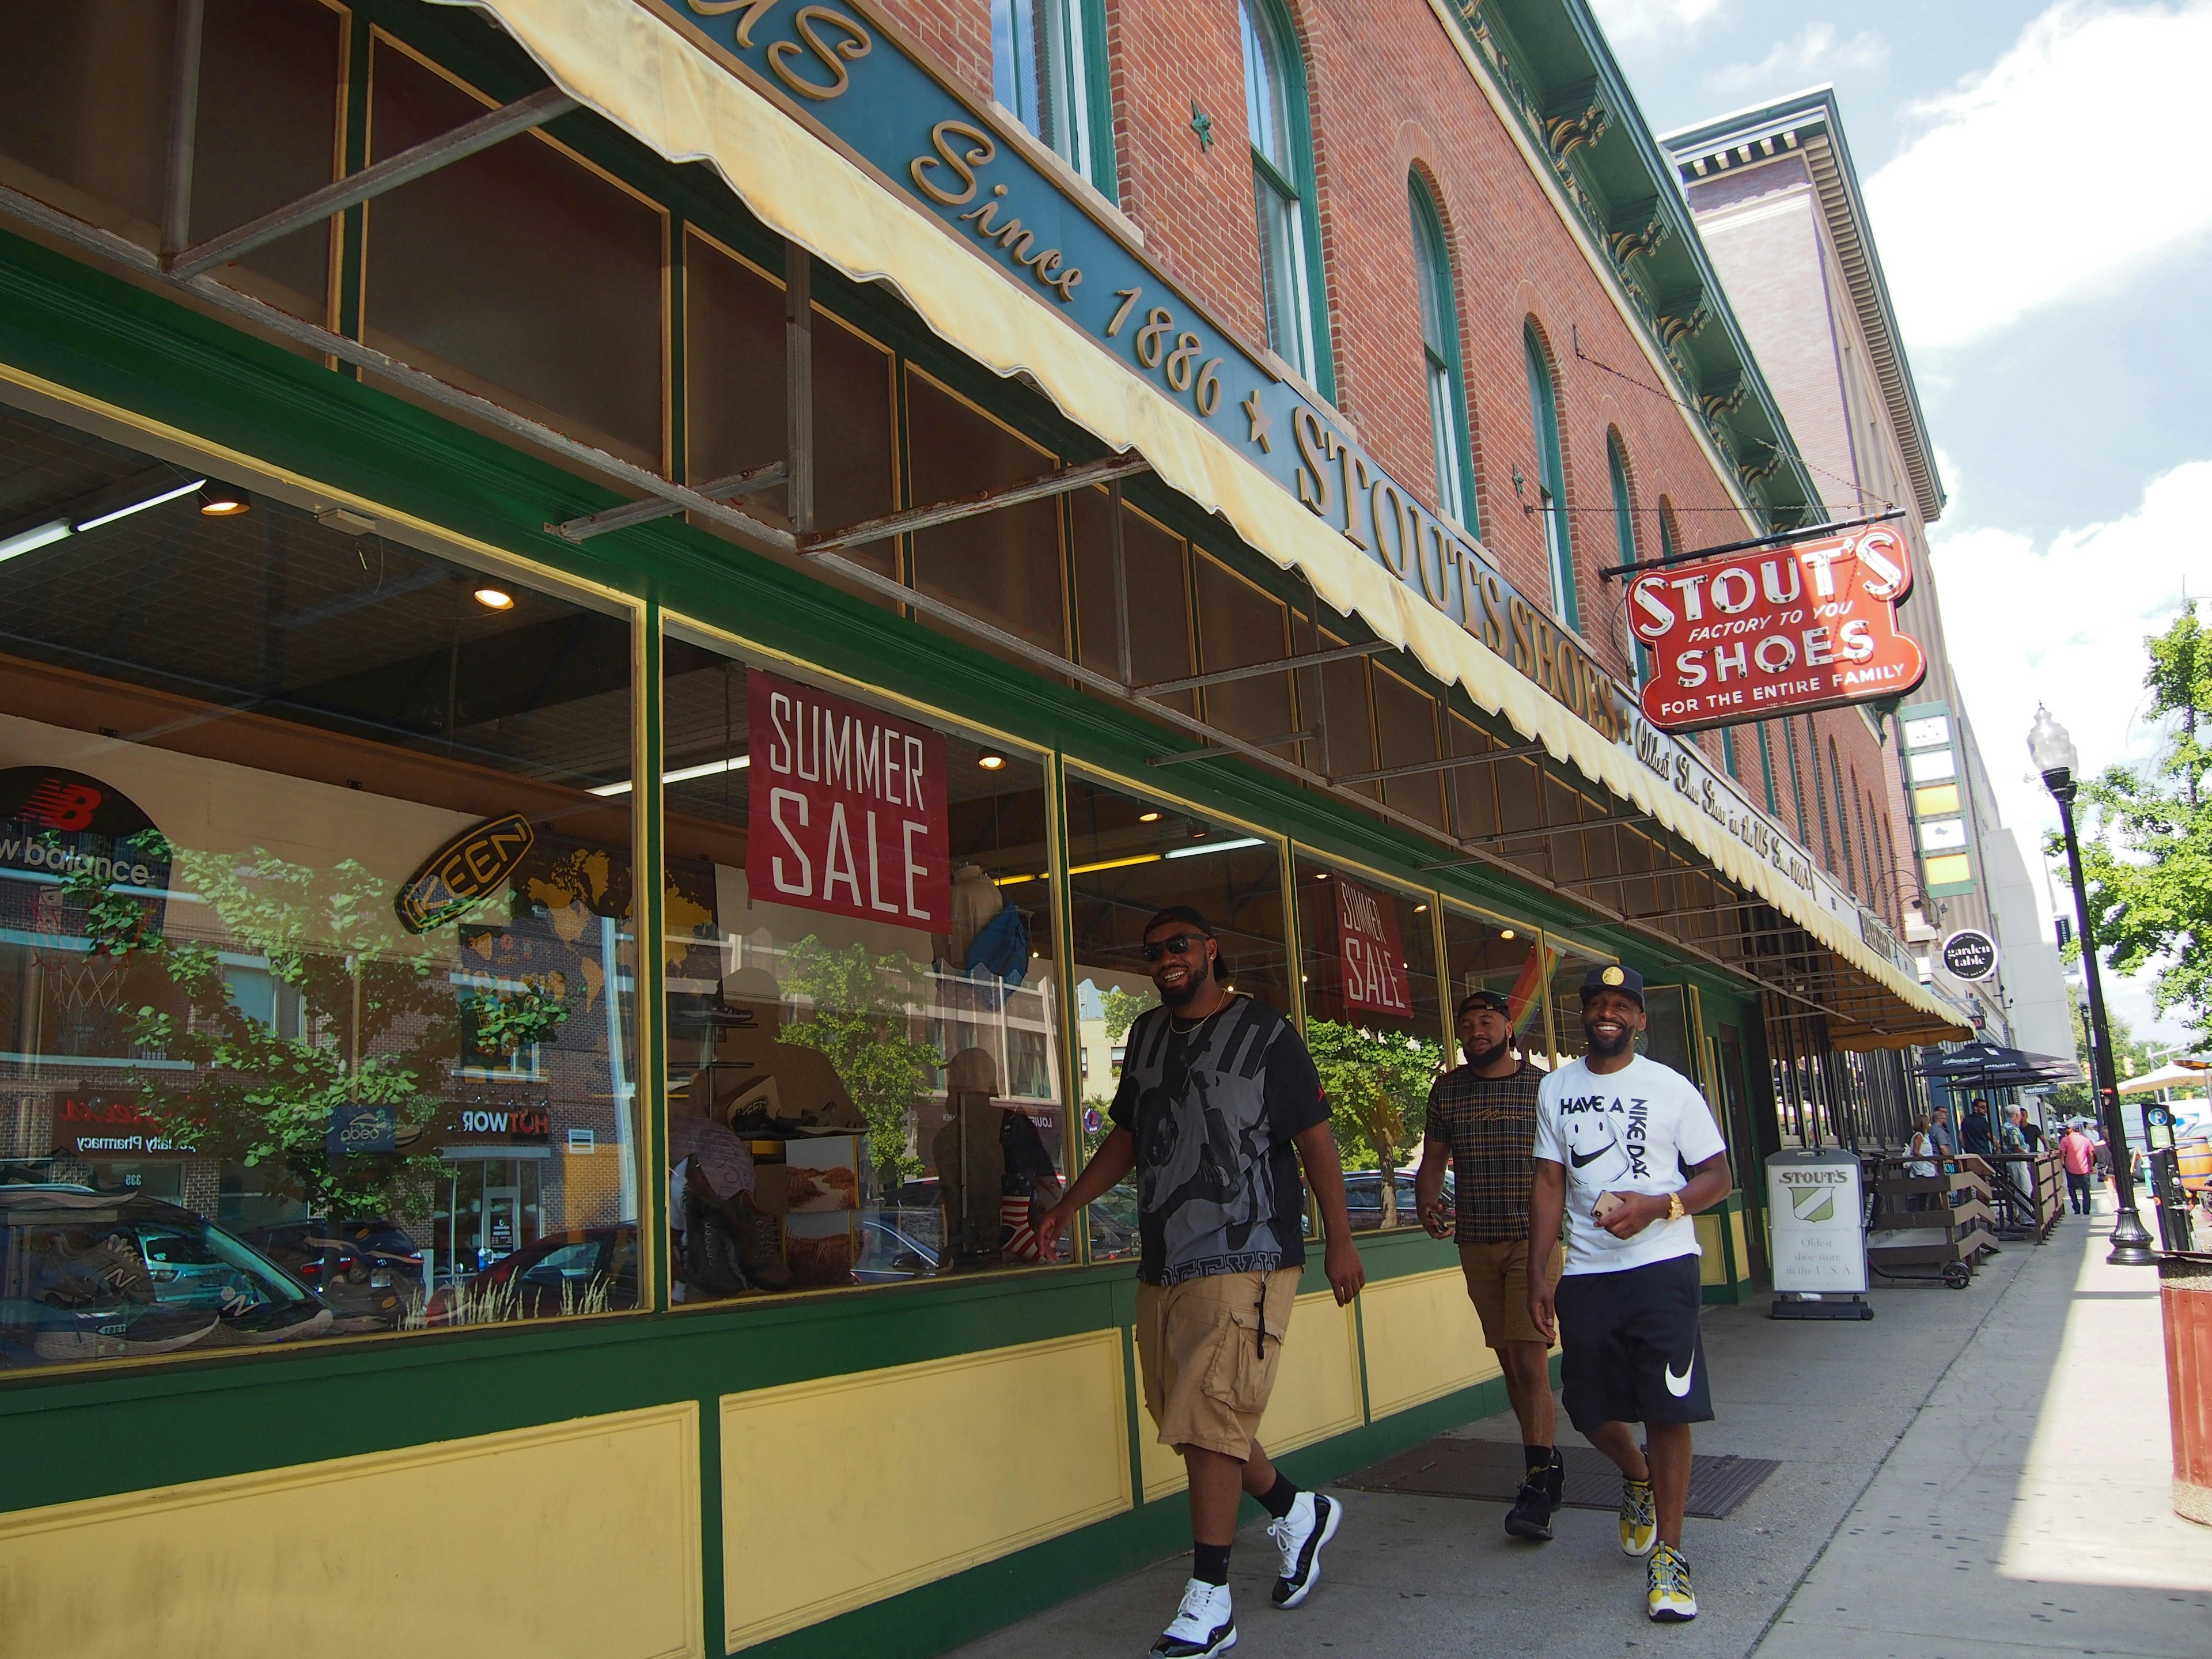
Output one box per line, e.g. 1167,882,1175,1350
721,1330,1130,1650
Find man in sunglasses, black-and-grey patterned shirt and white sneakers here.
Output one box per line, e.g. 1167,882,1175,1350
1037,905,1367,1659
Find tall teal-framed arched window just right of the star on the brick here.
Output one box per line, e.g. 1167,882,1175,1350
1237,0,1336,396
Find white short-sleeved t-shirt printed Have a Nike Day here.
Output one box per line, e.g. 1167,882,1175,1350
1535,1055,1728,1274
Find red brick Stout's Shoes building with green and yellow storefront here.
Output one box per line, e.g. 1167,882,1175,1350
0,0,1964,1659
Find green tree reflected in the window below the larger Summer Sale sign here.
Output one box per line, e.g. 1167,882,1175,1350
781,933,945,1177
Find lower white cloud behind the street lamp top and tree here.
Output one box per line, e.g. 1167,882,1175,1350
1931,458,2212,1037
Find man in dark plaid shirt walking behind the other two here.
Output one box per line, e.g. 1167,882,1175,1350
1414,991,1566,1541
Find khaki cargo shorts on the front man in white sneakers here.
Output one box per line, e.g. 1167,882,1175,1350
1137,1267,1298,1462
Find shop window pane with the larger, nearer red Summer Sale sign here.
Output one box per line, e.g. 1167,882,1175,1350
661,632,1071,1303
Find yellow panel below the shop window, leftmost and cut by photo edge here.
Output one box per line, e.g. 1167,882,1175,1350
0,1400,706,1659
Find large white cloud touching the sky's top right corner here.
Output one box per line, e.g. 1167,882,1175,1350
1867,0,2212,350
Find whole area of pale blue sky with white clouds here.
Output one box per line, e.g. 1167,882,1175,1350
1593,0,2212,1040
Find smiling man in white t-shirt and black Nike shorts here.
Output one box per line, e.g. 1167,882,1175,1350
1528,967,1730,1624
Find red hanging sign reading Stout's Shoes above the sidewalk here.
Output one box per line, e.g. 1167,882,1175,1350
1628,527,1927,732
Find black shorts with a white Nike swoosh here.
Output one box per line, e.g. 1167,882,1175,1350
1557,1256,1712,1433
